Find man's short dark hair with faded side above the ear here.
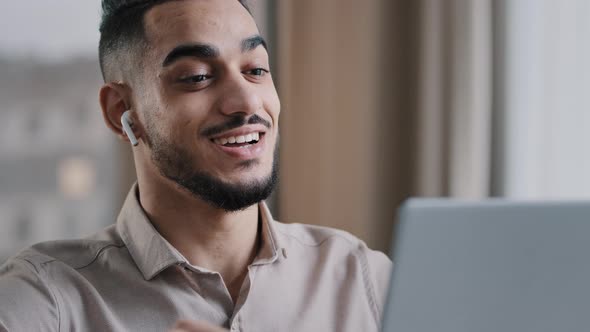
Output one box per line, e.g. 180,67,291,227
98,0,250,82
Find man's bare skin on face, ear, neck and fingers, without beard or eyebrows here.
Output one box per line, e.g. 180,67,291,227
100,0,280,331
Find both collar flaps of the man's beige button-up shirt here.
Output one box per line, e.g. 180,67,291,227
117,183,285,280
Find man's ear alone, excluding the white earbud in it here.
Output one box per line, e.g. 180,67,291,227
99,82,142,142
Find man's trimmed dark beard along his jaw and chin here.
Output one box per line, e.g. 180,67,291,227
146,121,278,212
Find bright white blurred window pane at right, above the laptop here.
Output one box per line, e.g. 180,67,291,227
503,0,590,198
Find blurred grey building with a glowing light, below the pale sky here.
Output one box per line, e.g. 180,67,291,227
0,59,118,261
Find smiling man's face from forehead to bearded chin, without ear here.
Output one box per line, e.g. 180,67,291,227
137,0,280,210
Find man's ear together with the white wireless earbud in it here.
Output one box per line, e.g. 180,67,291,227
99,83,141,146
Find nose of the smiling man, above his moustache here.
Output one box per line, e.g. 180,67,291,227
219,75,262,116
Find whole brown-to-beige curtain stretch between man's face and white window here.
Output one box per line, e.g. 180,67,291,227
277,0,500,251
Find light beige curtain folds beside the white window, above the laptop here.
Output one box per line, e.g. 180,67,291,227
415,0,493,198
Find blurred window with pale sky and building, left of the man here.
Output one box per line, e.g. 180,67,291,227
0,0,121,262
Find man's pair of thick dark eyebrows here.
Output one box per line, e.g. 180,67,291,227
162,35,268,67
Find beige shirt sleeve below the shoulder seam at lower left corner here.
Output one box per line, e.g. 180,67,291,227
0,258,59,332
